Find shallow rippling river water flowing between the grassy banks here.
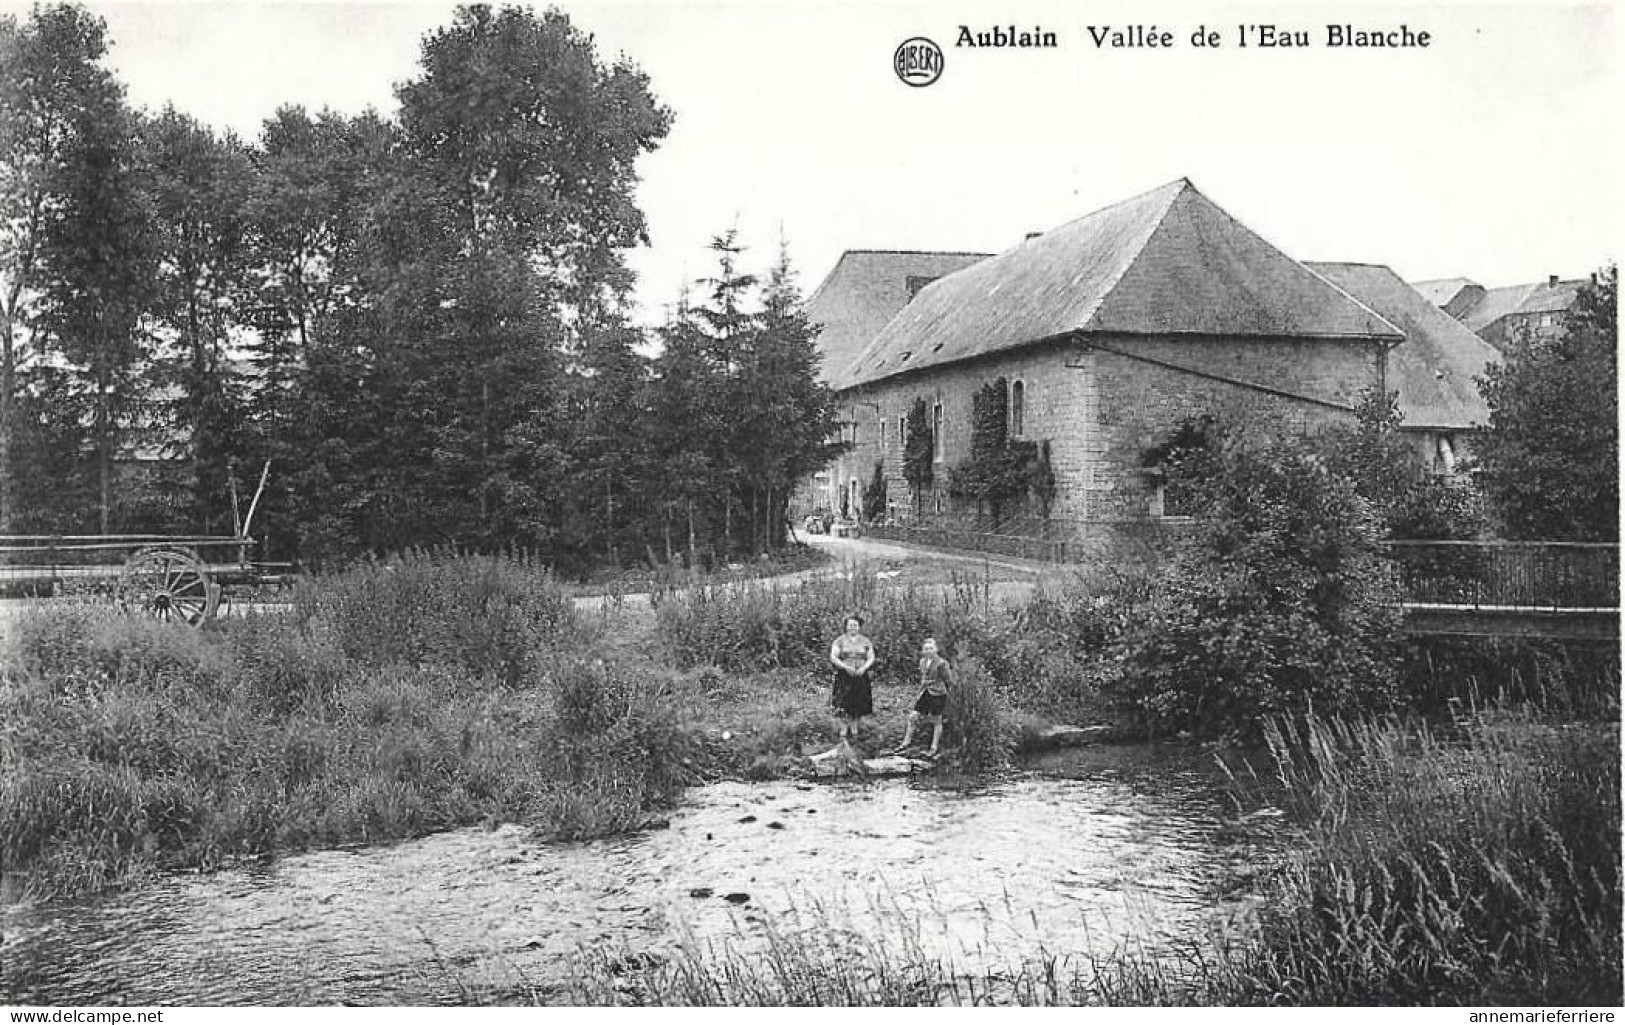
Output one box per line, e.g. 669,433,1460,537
0,747,1258,1006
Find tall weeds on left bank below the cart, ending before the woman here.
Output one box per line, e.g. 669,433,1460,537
0,557,684,895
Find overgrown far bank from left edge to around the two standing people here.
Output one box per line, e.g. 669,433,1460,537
0,552,1017,895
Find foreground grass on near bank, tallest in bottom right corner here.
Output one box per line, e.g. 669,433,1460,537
552,715,1622,1006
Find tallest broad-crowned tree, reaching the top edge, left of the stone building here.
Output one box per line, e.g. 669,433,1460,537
276,5,668,562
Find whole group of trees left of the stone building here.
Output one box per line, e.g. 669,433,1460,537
0,5,858,572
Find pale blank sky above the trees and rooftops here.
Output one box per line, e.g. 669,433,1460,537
0,0,1625,323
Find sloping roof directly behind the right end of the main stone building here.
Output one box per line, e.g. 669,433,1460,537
1310,263,1498,429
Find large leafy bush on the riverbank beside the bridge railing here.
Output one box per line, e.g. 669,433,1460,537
1113,434,1401,733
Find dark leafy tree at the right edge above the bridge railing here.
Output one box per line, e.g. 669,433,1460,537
1477,265,1619,541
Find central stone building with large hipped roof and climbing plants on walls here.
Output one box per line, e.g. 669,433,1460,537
809,179,1410,539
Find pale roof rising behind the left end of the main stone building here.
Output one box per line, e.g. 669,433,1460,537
806,249,988,383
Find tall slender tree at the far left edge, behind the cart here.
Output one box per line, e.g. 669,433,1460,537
0,5,153,530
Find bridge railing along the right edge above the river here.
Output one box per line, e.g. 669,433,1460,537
1388,541,1620,609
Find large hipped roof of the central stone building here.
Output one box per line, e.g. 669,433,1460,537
832,179,1401,388
